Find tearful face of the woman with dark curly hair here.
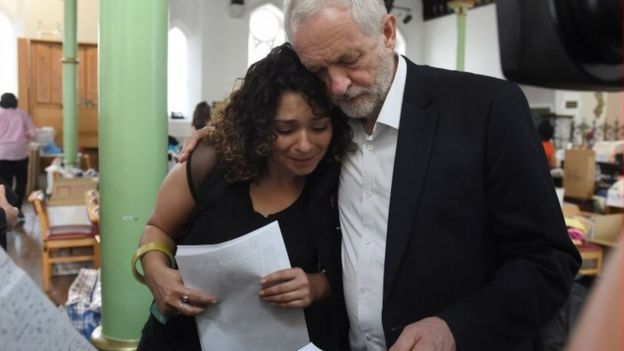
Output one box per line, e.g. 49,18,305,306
268,92,333,176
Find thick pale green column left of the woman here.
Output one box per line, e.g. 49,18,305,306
93,0,168,350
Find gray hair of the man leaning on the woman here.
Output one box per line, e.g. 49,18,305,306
284,0,388,42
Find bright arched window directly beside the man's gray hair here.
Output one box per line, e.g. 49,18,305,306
247,4,286,66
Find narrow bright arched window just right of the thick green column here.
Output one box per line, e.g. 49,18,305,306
167,27,189,117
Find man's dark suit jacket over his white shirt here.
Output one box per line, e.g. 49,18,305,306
382,60,580,351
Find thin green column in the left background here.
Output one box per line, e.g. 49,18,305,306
62,0,78,167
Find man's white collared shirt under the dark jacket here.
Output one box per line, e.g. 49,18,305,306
338,56,407,351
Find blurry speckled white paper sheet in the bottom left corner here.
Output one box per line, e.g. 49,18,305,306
0,248,95,351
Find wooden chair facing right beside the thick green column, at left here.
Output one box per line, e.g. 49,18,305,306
28,190,100,291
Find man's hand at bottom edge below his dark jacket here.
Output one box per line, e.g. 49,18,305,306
390,317,455,351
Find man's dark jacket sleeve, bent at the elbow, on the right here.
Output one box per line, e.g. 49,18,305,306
439,83,581,350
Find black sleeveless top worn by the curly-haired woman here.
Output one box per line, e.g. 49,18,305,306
138,144,349,351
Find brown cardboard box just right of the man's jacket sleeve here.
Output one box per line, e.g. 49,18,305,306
563,149,596,200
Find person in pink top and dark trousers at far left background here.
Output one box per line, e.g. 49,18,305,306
0,93,35,218
